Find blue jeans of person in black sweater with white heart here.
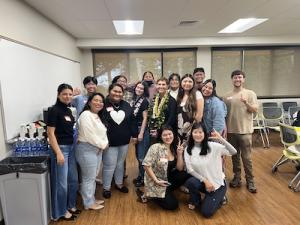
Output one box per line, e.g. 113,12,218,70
102,145,128,190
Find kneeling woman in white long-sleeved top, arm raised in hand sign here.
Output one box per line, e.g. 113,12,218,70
184,123,236,217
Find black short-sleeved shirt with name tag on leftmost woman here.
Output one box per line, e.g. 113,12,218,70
47,100,75,145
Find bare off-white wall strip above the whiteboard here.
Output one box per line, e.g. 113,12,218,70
0,0,81,61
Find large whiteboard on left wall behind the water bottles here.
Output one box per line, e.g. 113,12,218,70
0,39,81,140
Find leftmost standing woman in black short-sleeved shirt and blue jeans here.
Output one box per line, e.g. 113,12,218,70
47,83,81,221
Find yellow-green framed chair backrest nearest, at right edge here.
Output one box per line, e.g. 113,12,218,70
279,123,300,146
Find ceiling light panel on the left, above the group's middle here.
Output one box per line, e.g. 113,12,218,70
113,20,144,35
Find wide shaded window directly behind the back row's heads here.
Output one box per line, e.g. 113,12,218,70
93,48,197,93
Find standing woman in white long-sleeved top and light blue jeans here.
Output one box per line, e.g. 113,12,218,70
76,93,108,210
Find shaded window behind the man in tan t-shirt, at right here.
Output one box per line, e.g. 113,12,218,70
212,47,300,97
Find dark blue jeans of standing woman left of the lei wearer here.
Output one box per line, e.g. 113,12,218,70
135,127,150,180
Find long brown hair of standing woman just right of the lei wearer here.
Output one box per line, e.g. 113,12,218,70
177,74,197,119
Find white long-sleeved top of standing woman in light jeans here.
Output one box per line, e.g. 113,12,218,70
78,110,108,149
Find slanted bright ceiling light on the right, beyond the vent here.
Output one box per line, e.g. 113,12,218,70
218,18,268,33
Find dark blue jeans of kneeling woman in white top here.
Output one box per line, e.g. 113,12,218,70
185,177,227,218
